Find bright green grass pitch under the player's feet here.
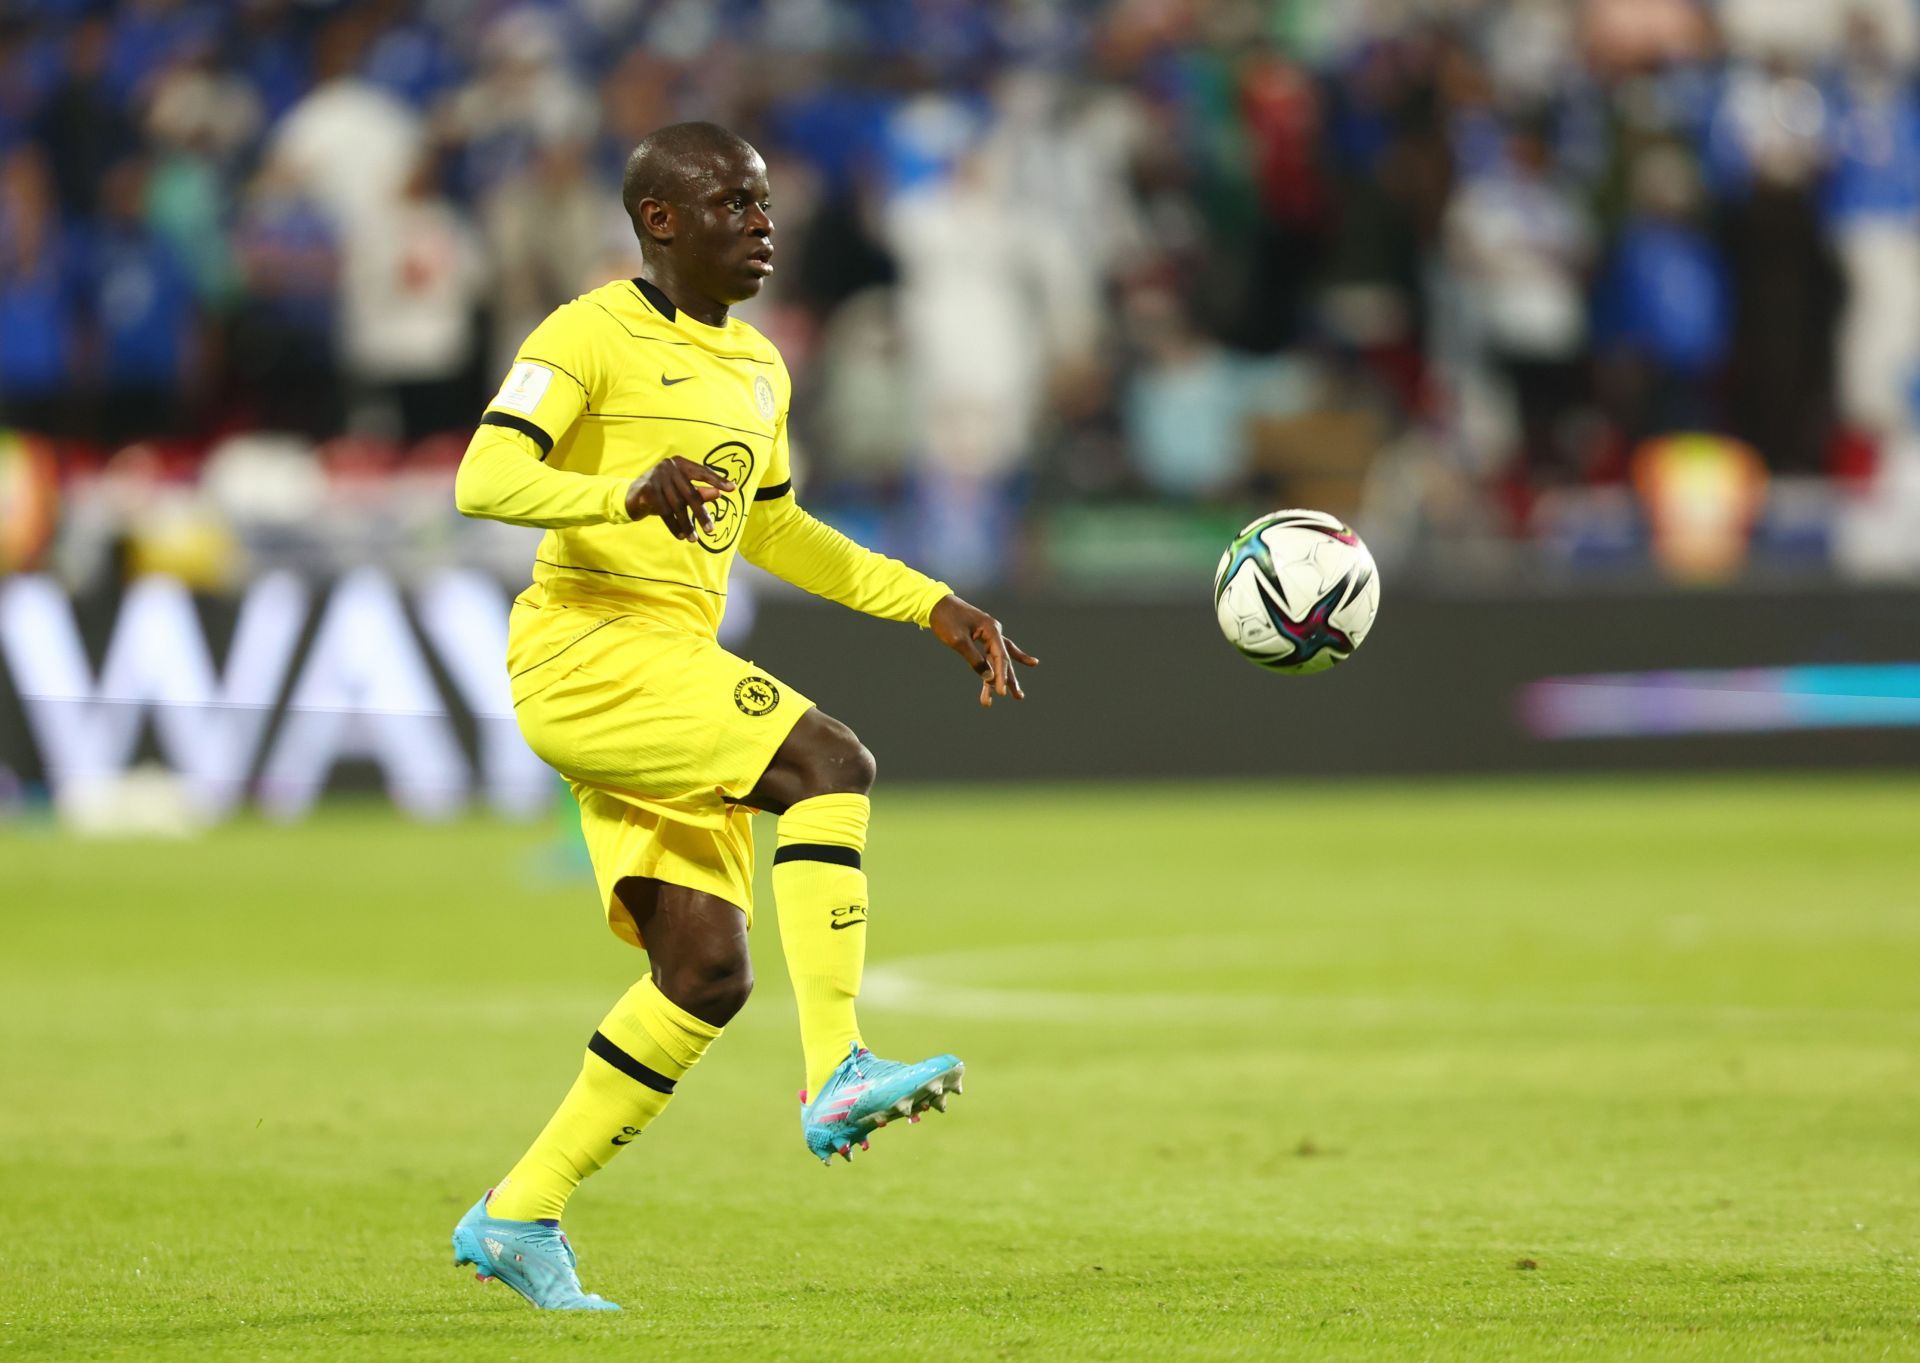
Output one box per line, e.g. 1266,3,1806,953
0,779,1920,1363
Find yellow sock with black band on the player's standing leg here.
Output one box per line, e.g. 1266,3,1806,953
488,977,720,1221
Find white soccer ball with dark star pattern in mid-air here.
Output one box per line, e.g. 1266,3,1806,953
1213,511,1380,672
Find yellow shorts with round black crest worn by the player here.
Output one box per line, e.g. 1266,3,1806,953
507,593,814,946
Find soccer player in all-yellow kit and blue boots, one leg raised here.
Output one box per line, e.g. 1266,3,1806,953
441,123,1037,1311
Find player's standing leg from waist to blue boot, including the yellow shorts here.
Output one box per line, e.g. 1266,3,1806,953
453,618,775,1309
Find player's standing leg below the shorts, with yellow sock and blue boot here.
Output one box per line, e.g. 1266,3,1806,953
453,877,753,1309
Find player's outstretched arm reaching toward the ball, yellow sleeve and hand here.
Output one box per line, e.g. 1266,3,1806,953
741,485,1039,705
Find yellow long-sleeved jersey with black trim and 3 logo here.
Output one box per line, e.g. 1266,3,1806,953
455,280,948,637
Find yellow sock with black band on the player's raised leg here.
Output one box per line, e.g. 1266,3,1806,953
774,795,872,1094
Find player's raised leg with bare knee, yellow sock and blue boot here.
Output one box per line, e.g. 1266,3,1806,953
745,710,964,1160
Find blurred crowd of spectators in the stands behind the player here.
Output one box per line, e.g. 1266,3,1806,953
0,0,1920,576
